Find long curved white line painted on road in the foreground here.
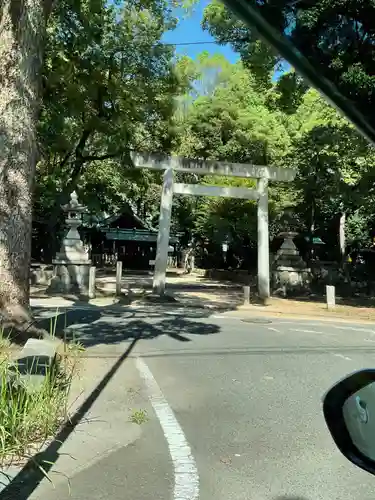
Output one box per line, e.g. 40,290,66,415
136,358,199,500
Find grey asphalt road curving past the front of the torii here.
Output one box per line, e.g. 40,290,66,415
33,308,375,500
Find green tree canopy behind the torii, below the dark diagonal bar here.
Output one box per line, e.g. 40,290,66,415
35,23,373,265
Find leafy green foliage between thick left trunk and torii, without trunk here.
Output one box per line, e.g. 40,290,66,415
35,0,184,225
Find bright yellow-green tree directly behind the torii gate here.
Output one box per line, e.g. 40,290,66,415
174,56,291,265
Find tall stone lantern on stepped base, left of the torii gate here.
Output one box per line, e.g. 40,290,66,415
48,192,91,296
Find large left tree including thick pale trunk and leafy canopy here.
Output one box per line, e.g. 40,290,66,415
0,0,184,316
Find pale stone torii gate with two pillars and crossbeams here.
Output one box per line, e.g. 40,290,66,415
131,152,296,299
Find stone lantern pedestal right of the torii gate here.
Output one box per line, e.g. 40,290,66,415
272,232,311,294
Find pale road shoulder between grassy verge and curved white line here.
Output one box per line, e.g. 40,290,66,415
30,357,148,499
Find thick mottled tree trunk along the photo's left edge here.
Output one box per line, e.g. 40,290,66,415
0,0,51,320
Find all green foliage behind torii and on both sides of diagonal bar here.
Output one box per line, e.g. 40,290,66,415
35,0,375,265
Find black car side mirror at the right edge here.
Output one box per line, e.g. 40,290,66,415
323,369,375,475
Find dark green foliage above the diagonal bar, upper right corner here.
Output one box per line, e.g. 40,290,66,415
284,0,375,131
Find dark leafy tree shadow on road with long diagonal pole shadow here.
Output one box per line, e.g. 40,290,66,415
0,300,220,500
